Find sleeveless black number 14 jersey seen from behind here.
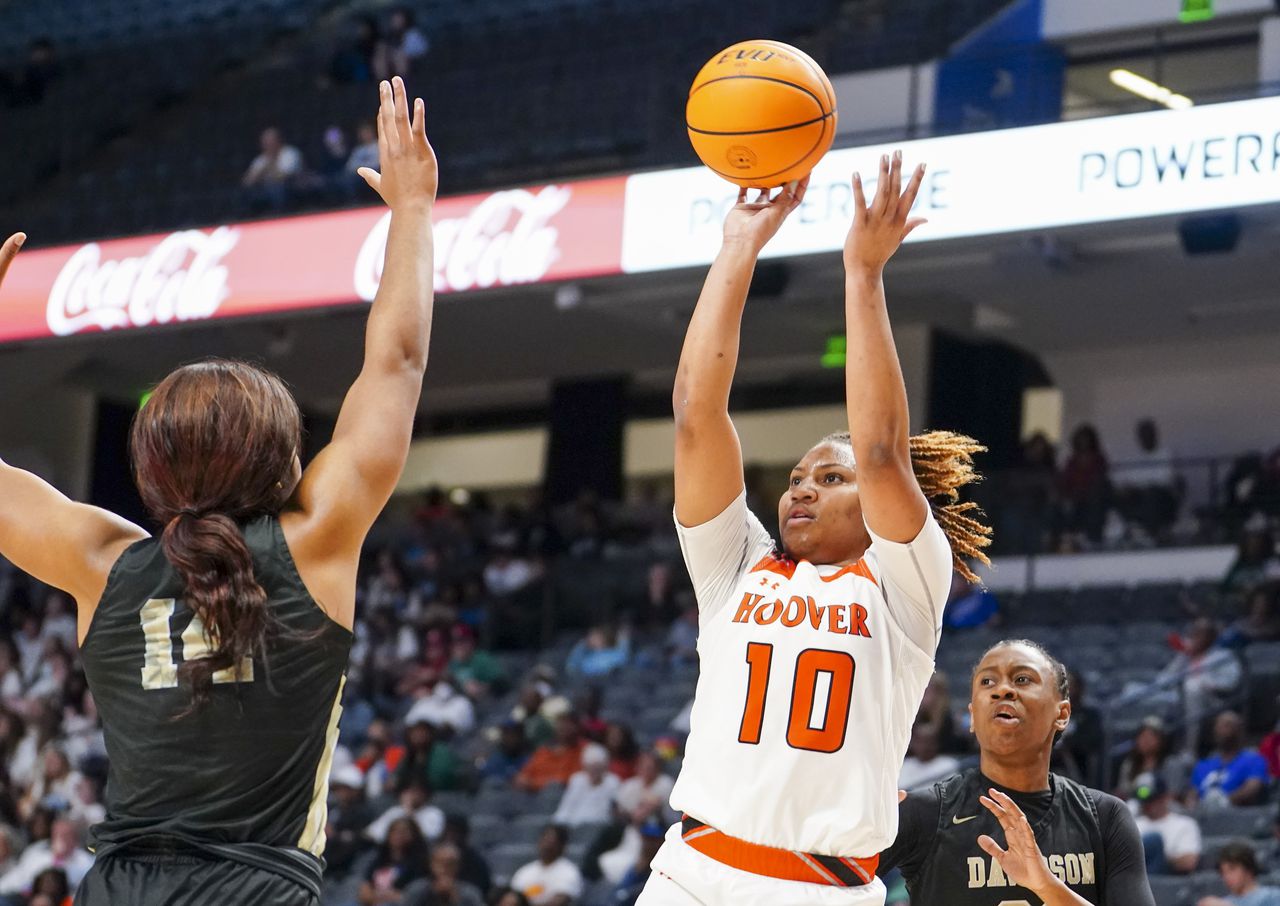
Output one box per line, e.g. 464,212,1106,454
81,517,352,877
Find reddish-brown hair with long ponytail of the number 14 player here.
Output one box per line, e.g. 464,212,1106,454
129,360,302,713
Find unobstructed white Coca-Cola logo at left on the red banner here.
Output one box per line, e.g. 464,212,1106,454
46,227,239,337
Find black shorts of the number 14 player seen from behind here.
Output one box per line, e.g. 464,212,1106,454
76,852,319,906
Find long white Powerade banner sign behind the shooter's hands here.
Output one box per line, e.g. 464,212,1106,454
622,97,1280,273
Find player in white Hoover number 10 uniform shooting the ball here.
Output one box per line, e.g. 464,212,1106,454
639,155,989,906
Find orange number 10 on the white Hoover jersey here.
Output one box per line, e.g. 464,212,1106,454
737,642,855,752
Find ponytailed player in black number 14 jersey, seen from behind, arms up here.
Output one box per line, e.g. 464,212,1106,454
0,78,436,906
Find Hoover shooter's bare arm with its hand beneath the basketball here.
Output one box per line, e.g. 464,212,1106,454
671,178,809,526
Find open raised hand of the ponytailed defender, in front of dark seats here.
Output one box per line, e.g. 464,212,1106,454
356,76,439,211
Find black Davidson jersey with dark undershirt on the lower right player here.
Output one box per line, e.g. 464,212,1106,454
879,768,1153,906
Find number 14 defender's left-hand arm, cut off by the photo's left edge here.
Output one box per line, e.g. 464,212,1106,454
0,233,147,621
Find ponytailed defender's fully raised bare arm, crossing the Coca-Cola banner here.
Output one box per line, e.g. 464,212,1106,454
291,77,438,624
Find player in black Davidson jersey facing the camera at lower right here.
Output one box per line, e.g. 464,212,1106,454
881,640,1156,906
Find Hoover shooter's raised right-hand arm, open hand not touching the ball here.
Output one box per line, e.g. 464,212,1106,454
845,152,928,543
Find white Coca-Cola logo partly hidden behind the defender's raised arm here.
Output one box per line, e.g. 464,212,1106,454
355,186,572,302
